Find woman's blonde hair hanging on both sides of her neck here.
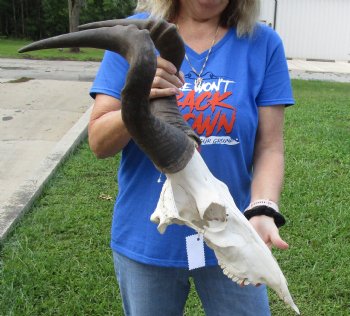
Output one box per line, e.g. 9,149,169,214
135,0,260,36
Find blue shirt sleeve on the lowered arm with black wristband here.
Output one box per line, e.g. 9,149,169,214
256,32,294,106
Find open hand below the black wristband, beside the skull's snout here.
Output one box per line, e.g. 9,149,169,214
249,215,289,249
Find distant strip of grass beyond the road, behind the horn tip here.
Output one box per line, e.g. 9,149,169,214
0,38,103,61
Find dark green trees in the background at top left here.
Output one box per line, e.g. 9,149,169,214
0,0,136,40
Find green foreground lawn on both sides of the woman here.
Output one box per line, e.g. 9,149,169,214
0,81,350,316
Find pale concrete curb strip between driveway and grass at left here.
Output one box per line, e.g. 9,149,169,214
0,106,92,243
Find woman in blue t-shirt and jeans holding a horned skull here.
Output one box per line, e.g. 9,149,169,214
89,0,294,316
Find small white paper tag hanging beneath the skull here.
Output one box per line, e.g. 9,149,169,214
186,234,205,270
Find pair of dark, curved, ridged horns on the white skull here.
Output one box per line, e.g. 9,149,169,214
19,19,200,173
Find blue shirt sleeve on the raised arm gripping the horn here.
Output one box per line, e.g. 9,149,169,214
90,51,129,100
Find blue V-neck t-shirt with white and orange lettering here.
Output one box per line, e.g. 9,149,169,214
91,15,294,267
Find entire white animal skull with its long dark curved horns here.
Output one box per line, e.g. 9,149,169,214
20,19,299,314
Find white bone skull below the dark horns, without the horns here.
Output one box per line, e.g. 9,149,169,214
151,151,299,314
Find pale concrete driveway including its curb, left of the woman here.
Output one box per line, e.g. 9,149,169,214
0,60,98,240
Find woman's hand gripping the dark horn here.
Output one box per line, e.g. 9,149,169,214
150,56,185,99
